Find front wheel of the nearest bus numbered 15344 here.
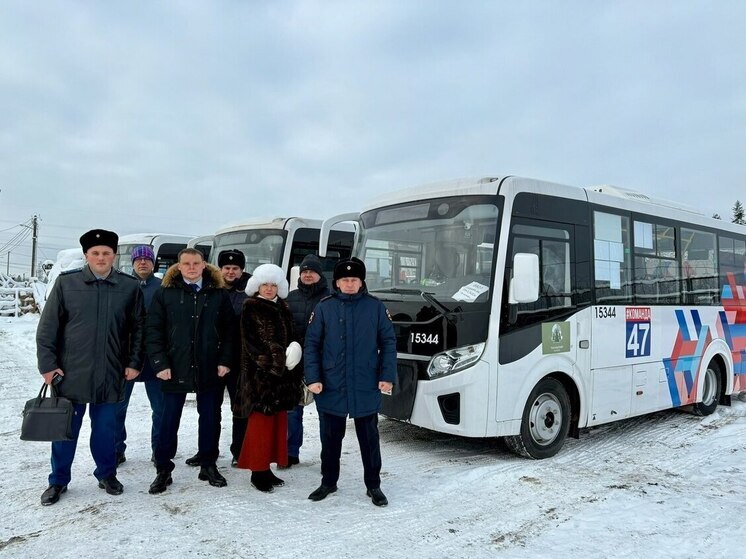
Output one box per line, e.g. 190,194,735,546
505,377,570,460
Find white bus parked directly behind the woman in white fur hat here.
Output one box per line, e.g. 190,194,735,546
210,217,355,282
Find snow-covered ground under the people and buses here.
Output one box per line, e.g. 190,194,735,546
0,315,746,559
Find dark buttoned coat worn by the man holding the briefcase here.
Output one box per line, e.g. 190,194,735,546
36,266,144,404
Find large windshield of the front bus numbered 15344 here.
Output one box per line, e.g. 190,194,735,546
357,196,499,305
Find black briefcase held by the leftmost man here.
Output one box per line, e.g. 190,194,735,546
21,383,73,442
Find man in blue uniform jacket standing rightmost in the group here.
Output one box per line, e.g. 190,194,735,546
304,258,396,507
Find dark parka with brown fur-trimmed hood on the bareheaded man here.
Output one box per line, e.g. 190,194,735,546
145,264,234,392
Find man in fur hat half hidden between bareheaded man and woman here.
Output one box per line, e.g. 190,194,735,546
185,249,251,468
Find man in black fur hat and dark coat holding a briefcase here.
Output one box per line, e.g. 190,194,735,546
36,229,143,505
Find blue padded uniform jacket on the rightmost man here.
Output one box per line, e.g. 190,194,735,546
303,284,396,417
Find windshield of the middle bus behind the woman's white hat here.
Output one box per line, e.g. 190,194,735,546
210,229,287,273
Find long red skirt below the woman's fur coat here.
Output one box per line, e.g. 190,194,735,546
238,411,288,472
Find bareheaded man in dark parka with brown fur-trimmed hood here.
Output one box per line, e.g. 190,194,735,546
145,248,234,494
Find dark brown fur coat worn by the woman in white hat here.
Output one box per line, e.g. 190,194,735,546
233,295,302,417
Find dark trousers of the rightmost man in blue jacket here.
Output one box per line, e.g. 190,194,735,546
319,412,381,489
